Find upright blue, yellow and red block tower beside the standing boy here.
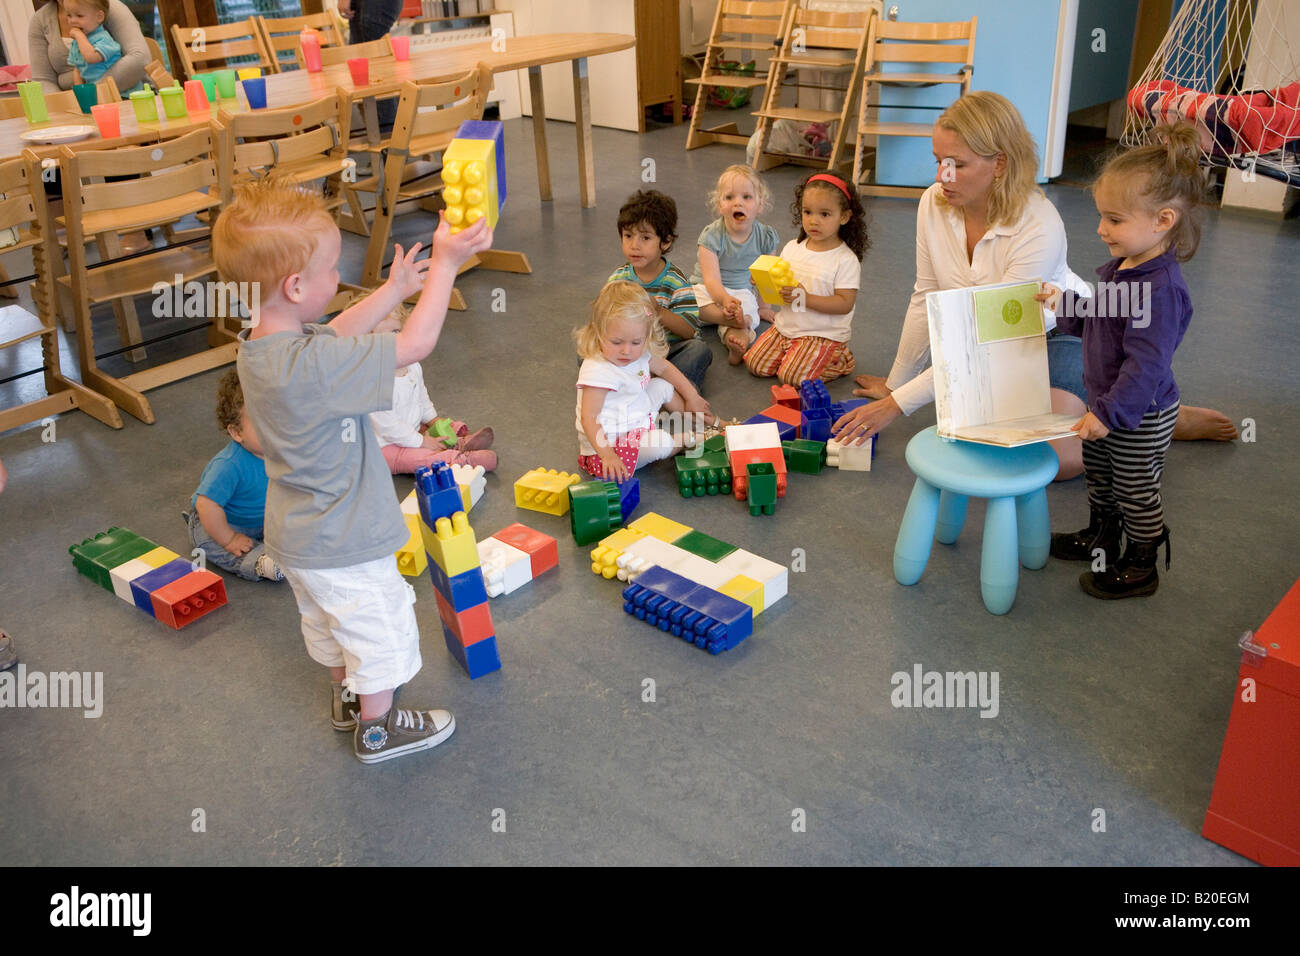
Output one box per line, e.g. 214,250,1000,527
415,462,501,678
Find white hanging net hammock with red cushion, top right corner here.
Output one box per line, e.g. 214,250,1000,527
1121,0,1300,186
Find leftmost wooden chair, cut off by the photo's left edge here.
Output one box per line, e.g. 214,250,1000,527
0,150,122,432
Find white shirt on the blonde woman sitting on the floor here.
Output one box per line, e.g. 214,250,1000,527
887,182,1088,415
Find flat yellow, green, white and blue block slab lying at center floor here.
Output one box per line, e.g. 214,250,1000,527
592,512,789,654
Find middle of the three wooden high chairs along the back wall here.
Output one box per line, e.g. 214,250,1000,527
754,7,876,169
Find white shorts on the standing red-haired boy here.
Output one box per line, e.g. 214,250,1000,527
281,555,420,693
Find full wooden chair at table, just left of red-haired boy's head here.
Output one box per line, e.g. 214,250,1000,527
55,127,235,424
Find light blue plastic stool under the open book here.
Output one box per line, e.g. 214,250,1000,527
894,425,1058,614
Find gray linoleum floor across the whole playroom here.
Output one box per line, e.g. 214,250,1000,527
0,111,1300,865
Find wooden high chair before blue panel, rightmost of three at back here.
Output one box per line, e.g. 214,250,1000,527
853,17,979,196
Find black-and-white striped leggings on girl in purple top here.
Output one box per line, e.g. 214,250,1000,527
1083,402,1179,541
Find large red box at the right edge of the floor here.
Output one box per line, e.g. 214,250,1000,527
1201,581,1300,866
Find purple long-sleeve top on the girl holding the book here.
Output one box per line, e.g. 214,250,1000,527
1057,250,1192,431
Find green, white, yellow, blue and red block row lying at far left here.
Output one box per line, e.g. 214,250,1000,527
68,528,226,630
